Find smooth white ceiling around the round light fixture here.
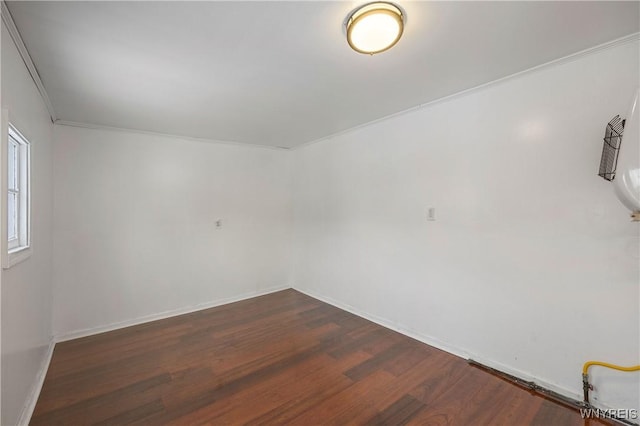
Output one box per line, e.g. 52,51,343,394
8,0,640,147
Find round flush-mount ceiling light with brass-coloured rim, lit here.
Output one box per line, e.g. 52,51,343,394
345,2,405,55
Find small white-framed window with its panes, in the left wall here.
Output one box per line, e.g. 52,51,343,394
0,117,31,268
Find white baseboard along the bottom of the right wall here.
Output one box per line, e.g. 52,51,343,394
293,285,624,409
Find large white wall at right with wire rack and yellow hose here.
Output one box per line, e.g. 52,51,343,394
293,41,640,408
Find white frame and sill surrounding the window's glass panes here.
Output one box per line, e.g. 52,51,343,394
0,110,32,269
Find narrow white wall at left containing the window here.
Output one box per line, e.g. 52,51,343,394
0,24,53,425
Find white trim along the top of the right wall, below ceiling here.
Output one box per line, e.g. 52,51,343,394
290,32,640,150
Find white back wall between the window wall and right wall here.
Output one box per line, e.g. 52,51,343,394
53,125,291,338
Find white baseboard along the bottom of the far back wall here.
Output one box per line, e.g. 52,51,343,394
54,285,291,343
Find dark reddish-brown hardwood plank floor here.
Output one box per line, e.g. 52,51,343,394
31,290,600,426
